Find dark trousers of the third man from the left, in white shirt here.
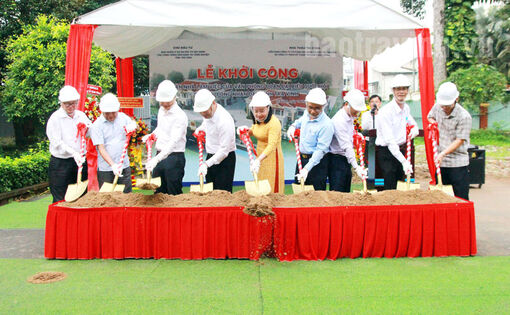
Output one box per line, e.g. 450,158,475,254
152,152,186,195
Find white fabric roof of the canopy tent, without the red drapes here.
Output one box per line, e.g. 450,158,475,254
74,0,423,60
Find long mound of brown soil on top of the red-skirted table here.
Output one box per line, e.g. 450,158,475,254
59,190,463,216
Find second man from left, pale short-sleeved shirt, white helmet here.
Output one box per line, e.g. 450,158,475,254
90,93,137,193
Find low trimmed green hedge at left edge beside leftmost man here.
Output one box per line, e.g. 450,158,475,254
0,141,50,193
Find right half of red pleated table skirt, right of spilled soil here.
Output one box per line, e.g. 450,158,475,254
273,202,476,261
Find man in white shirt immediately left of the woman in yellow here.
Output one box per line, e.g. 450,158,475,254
193,89,236,192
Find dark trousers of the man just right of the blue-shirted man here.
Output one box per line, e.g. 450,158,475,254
326,153,352,192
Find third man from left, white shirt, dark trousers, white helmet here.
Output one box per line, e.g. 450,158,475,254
142,80,188,195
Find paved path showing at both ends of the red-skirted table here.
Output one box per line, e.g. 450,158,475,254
0,178,510,258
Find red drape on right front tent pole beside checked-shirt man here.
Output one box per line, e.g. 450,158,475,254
415,28,436,184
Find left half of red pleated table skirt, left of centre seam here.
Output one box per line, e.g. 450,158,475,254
44,204,273,260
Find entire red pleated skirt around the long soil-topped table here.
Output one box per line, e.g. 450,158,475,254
45,202,476,261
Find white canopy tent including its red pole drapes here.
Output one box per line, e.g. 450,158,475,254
66,0,434,189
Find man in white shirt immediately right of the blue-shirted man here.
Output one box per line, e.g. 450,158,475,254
328,89,366,193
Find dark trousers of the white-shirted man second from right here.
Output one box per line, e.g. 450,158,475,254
375,144,406,190
